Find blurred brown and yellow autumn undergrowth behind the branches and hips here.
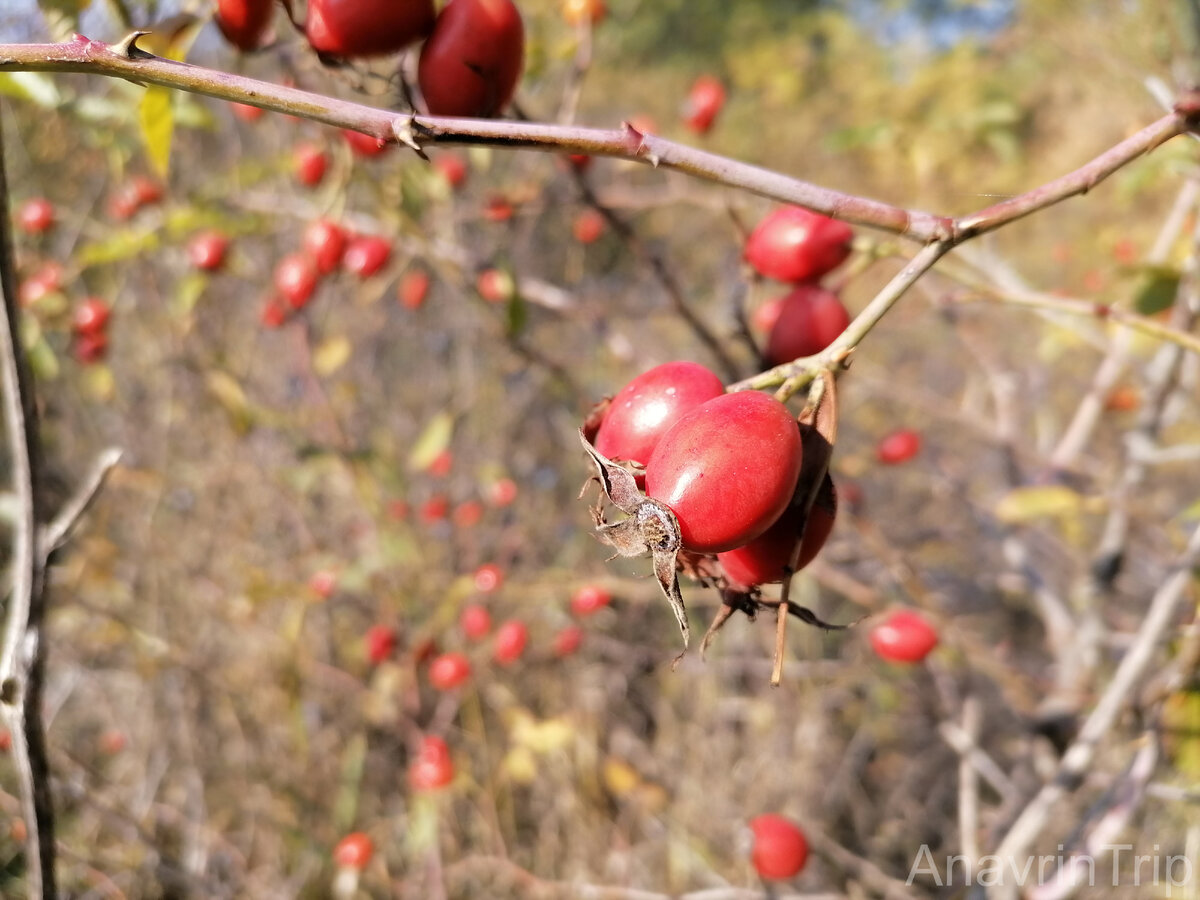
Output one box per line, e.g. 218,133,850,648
0,0,1200,898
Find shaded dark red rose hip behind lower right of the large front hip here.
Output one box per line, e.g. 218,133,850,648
716,475,838,588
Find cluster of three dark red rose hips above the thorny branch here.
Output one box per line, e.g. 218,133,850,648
216,0,524,116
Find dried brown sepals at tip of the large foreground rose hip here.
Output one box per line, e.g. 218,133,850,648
580,428,691,652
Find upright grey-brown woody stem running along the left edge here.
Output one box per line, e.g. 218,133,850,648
0,100,56,898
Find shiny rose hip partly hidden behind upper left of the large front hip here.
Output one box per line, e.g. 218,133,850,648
593,361,725,466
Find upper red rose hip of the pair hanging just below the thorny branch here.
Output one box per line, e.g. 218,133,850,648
745,206,854,283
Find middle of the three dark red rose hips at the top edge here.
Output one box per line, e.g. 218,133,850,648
305,0,433,56
